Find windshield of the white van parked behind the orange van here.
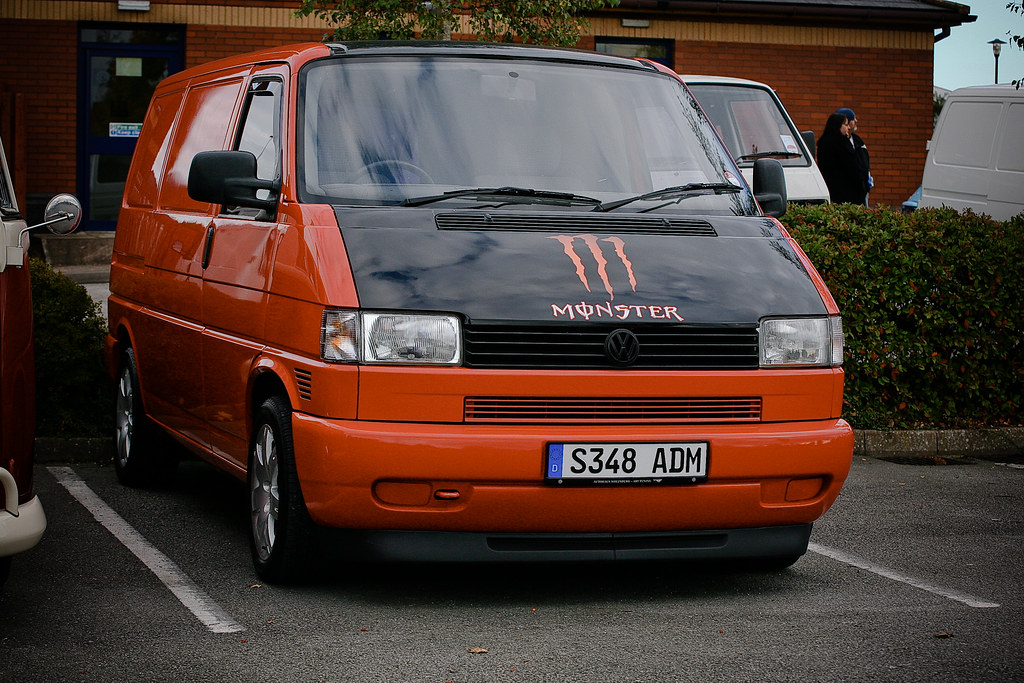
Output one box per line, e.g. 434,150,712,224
687,83,811,167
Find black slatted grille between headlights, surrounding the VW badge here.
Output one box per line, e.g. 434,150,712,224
465,323,758,370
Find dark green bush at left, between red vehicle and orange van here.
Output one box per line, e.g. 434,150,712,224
29,259,114,437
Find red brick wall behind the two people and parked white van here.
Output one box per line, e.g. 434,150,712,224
675,41,933,206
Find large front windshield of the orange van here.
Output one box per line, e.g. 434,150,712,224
298,56,757,214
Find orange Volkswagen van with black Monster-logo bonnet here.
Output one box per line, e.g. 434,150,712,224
108,43,853,581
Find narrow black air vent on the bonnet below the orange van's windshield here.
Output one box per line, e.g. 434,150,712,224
434,212,718,238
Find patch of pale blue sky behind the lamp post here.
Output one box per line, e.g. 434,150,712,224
933,0,1024,90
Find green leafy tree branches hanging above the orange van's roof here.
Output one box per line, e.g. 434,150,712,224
295,0,618,47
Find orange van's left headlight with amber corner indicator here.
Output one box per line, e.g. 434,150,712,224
321,310,462,366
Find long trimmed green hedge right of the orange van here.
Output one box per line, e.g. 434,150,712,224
783,205,1024,429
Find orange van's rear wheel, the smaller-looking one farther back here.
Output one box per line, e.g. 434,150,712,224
114,348,176,486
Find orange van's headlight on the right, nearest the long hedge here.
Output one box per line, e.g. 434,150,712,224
760,315,843,368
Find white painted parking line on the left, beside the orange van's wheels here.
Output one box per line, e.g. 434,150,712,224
46,467,245,633
